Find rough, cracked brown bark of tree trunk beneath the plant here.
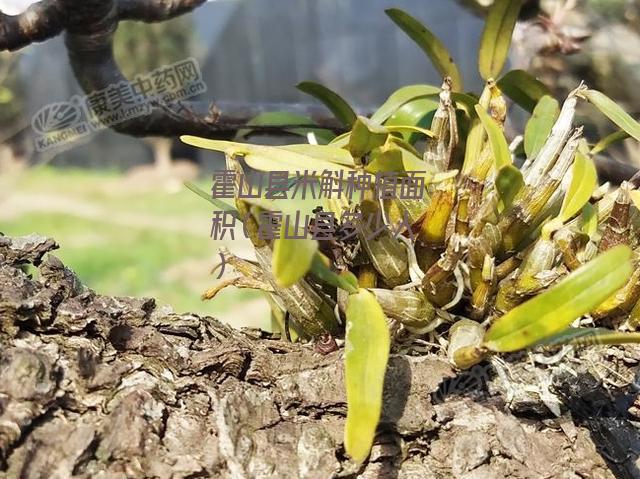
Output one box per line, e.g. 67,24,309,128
0,236,640,479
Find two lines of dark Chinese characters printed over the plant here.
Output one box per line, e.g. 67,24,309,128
210,170,425,241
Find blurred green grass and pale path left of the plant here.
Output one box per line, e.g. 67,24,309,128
0,167,269,327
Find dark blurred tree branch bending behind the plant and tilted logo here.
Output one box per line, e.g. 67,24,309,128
0,0,637,183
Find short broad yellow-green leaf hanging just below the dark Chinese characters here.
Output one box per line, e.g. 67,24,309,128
271,221,318,288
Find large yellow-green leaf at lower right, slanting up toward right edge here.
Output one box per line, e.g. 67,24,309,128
484,245,633,352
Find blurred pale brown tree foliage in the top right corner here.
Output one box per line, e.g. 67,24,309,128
459,0,640,167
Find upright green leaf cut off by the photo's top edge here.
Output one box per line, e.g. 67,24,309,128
478,0,522,80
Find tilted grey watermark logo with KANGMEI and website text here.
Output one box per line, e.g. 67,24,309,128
31,58,207,151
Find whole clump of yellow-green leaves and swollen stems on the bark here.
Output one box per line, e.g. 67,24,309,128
182,0,640,462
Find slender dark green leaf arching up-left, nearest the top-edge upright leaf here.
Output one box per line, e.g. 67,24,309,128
385,8,462,91
